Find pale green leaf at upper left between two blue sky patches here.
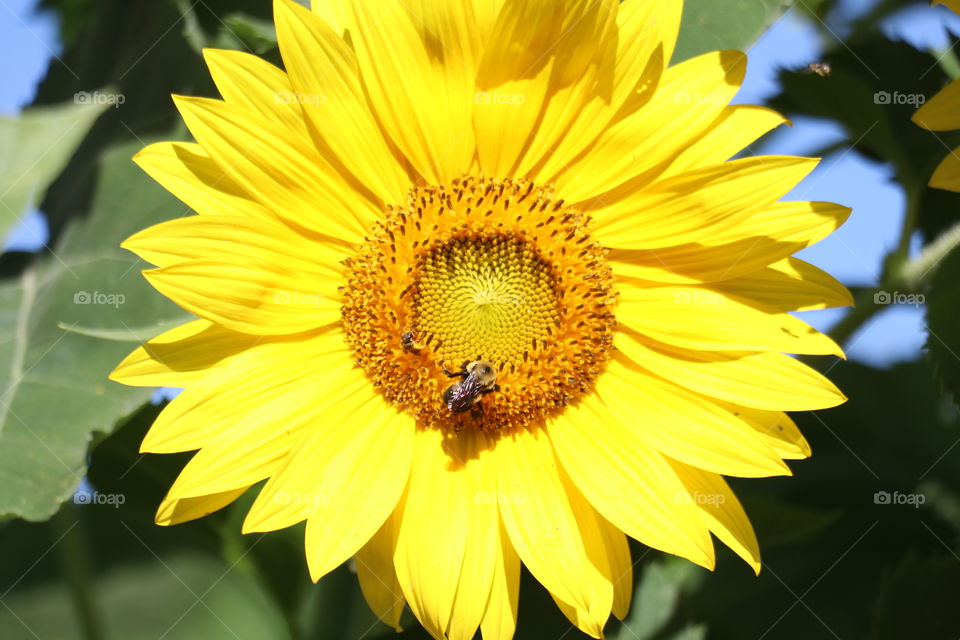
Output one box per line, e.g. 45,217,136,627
0,99,109,240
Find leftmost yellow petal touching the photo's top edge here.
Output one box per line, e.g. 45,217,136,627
274,0,411,204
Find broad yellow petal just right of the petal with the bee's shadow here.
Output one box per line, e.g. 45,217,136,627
497,424,632,620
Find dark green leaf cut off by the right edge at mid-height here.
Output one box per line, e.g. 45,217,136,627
926,249,960,403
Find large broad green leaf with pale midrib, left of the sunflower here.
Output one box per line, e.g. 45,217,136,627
0,143,188,520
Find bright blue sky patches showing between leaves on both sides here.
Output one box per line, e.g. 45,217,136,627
0,0,960,366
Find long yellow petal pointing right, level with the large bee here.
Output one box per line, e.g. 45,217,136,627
616,331,846,411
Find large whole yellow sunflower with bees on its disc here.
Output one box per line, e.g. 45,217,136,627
112,0,851,640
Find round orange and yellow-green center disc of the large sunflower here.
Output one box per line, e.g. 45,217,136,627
342,177,616,430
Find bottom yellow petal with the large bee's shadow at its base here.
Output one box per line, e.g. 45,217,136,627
394,429,498,640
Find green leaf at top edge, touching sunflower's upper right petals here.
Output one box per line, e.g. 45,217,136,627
672,0,790,64
